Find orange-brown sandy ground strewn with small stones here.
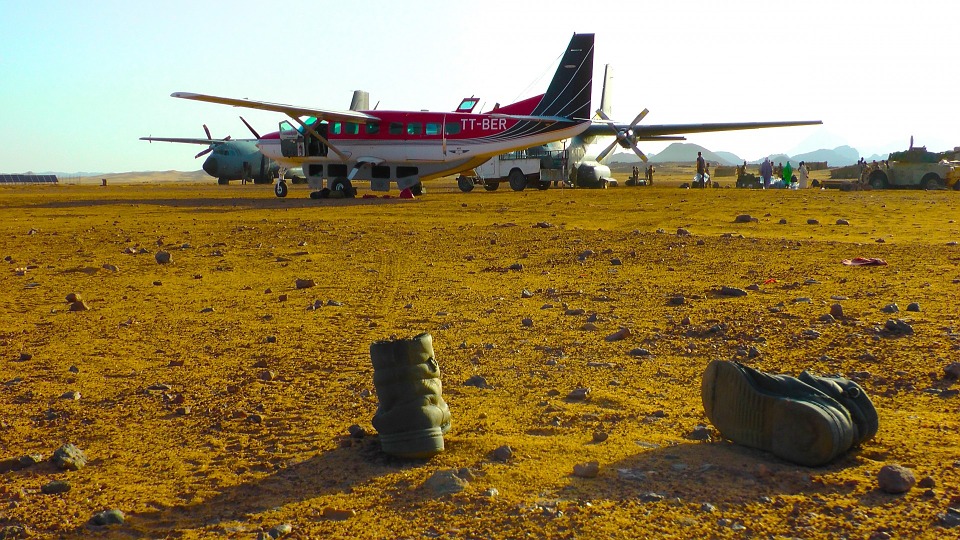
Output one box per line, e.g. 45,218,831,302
0,176,960,538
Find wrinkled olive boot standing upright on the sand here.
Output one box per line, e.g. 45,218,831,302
370,333,450,458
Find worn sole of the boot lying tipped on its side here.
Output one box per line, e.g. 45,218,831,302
701,360,845,467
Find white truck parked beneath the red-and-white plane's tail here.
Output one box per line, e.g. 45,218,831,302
457,147,567,193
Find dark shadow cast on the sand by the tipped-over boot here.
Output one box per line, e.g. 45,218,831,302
565,441,856,506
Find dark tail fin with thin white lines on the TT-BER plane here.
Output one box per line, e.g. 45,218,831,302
533,34,593,120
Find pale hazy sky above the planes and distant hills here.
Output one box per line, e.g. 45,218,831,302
0,0,960,173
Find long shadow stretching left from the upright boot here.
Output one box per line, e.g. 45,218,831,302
128,437,410,534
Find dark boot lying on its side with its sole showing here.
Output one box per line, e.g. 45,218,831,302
700,360,878,467
